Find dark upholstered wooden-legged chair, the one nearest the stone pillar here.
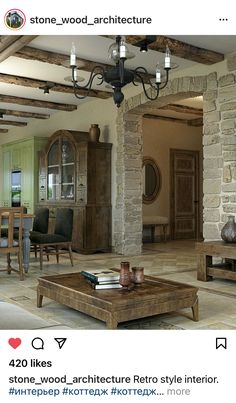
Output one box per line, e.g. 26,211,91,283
30,208,73,270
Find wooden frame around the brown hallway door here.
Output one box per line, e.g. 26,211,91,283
169,148,200,240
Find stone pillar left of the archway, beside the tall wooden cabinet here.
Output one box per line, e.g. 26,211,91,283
113,111,143,255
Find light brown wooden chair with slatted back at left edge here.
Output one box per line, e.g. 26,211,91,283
0,207,24,280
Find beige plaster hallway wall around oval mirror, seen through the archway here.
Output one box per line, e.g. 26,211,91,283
143,119,202,227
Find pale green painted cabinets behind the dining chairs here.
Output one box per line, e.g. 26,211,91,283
0,137,47,213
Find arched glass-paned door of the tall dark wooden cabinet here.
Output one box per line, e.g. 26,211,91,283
47,137,75,201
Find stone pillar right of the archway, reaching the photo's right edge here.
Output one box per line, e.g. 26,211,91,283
203,55,236,240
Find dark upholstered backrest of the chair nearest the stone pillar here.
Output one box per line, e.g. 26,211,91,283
54,208,74,241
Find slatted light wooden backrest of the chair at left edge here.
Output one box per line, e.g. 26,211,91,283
0,207,23,253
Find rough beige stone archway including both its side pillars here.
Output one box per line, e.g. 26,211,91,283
113,59,236,255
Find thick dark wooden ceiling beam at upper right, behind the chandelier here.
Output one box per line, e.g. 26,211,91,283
125,35,224,65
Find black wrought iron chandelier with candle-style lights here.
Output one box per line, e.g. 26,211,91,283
70,36,171,107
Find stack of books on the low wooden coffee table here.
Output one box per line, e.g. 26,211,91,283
81,269,122,290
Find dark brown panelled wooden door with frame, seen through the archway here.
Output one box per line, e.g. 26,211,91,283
170,149,199,239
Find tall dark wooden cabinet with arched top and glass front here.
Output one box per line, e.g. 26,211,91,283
39,130,112,253
